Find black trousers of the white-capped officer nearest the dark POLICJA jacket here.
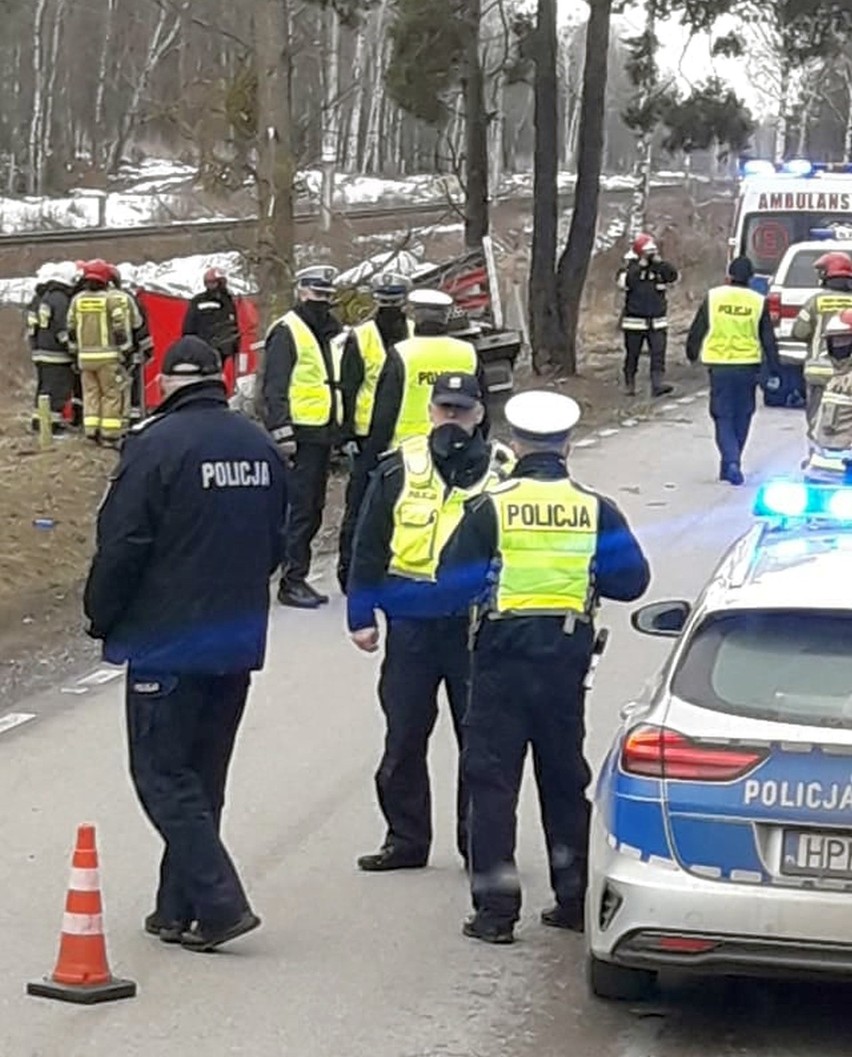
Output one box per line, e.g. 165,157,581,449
283,441,331,583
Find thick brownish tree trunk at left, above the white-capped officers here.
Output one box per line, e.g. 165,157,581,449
255,0,294,323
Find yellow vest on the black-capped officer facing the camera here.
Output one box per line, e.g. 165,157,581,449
388,437,511,580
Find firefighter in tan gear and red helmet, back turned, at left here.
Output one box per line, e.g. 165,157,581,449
68,258,145,446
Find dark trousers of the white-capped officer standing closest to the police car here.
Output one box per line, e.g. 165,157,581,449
464,649,591,925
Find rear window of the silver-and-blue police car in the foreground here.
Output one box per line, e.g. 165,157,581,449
671,610,852,728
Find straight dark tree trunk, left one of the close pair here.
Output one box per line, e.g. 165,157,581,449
530,0,563,367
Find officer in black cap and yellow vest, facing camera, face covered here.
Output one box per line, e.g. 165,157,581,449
348,373,509,871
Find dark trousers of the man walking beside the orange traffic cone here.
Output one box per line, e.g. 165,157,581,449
127,670,251,926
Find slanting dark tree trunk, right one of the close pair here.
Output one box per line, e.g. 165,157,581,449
558,0,612,374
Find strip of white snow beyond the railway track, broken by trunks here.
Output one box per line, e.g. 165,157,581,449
0,159,684,235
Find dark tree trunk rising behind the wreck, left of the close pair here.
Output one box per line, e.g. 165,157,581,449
464,0,488,248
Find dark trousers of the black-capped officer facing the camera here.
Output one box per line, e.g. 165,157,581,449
375,617,470,861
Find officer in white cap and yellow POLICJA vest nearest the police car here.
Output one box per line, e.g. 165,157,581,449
439,392,649,943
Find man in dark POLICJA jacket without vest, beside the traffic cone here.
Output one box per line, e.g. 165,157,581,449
85,337,286,951
